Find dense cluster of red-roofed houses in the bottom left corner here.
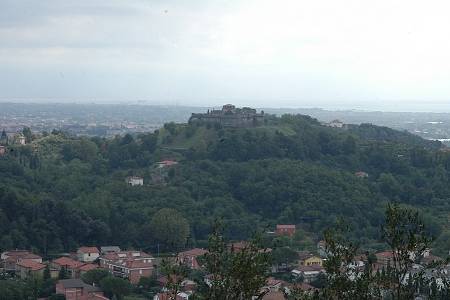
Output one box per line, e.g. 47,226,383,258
1,246,154,300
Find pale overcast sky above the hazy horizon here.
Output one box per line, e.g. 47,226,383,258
0,0,450,111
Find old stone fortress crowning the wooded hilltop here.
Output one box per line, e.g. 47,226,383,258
189,104,264,127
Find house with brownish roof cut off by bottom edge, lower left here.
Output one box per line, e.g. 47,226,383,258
56,279,109,300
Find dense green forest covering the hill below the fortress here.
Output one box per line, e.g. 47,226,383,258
0,115,450,256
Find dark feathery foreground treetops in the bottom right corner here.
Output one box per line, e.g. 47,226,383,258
287,204,449,300
